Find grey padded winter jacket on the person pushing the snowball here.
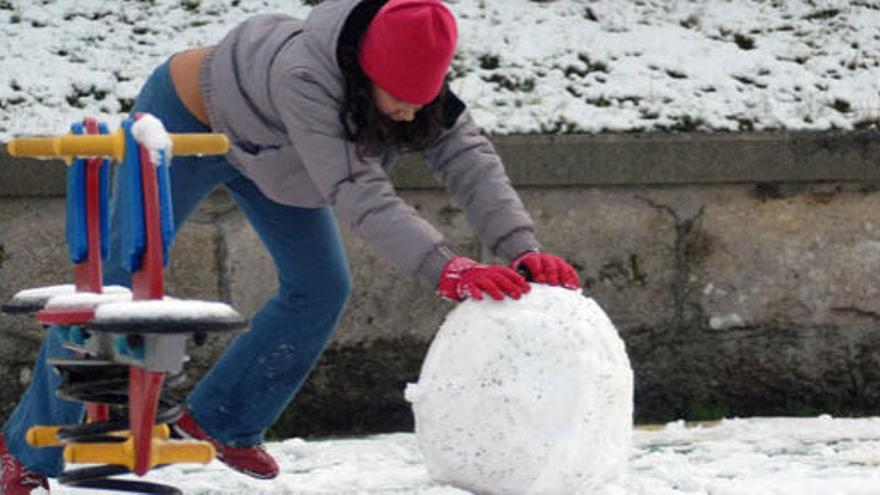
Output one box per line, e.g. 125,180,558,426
200,0,538,286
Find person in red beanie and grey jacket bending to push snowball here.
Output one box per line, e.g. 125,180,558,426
0,0,580,488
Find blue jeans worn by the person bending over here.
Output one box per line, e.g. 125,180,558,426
3,58,351,476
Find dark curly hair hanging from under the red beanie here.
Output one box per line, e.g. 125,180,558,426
337,0,448,159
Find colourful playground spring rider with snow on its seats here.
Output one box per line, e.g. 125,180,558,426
3,115,246,494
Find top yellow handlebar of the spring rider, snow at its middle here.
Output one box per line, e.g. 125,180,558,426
7,129,229,161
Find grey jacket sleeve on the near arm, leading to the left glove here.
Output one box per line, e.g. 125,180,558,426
273,68,454,287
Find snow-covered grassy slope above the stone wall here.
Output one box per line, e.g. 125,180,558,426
0,0,880,141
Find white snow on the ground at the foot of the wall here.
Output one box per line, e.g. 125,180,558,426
46,416,880,495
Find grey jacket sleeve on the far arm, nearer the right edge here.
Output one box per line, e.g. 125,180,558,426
425,109,540,261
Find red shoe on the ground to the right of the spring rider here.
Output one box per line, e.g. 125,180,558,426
172,410,278,478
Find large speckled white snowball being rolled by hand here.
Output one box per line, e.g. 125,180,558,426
406,285,633,494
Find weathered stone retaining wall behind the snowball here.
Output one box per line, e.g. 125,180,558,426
0,132,880,436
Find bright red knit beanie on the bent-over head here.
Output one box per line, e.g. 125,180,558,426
360,0,458,105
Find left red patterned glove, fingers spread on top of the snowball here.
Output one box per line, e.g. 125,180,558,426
437,256,531,301
